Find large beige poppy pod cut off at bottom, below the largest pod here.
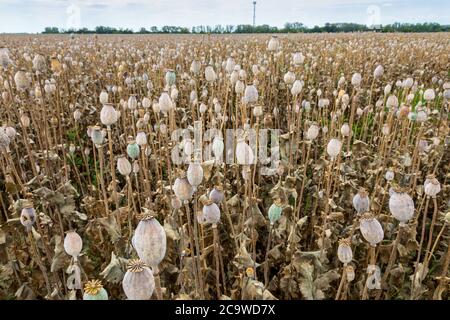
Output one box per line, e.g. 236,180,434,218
122,259,155,300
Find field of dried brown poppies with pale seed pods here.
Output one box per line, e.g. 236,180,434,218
0,33,450,300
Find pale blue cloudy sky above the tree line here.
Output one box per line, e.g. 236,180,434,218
0,0,450,33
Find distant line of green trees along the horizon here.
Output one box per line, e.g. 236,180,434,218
42,22,450,34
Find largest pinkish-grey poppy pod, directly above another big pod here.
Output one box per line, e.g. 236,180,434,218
132,214,167,268
